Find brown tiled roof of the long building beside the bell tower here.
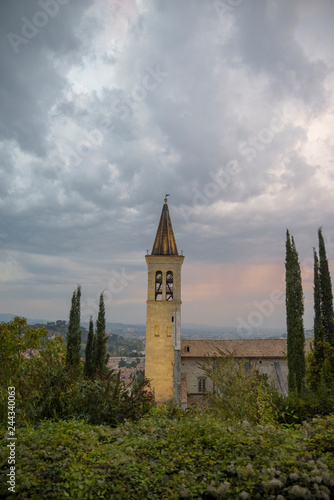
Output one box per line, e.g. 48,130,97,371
181,339,311,358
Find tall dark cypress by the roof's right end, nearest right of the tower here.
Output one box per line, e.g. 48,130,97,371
285,230,305,394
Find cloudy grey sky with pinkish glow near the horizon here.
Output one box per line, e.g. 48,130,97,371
0,0,334,332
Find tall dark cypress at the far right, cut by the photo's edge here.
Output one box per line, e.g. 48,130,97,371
318,227,334,346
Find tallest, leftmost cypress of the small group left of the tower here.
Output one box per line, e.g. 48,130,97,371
66,285,81,367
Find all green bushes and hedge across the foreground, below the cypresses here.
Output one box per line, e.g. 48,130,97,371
0,314,334,500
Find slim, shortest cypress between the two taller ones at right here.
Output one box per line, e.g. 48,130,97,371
313,248,324,365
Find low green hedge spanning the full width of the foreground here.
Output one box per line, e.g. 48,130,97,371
0,409,334,500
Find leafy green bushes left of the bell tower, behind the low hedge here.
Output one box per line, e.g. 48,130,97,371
0,324,151,427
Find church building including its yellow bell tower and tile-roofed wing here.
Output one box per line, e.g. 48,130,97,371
145,197,310,408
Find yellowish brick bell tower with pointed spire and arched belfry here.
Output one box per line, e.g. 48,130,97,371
145,195,184,402
